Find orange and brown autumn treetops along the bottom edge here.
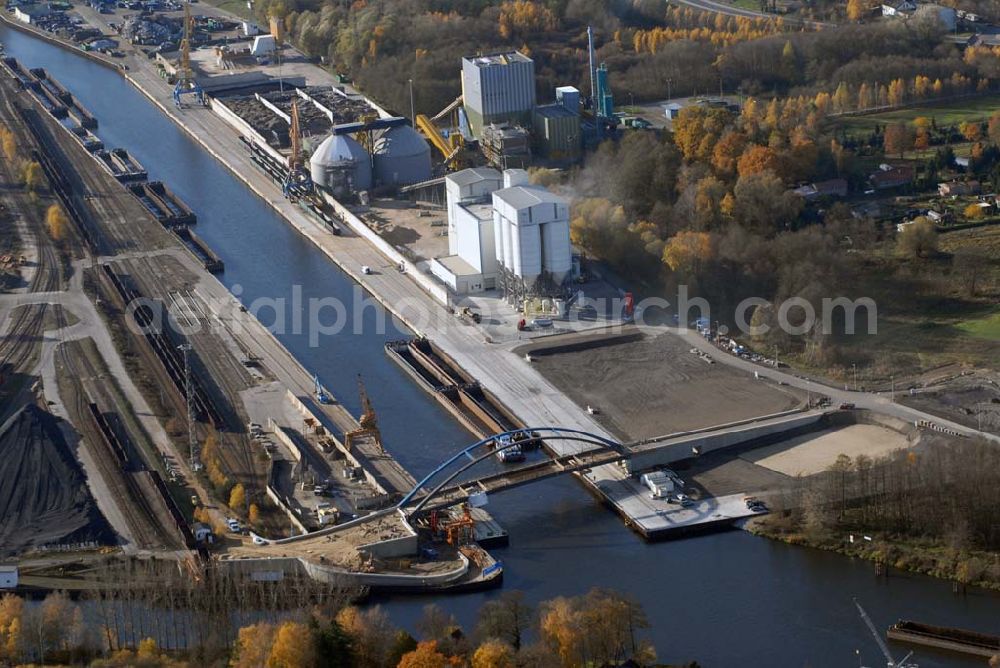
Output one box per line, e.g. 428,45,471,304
0,589,684,668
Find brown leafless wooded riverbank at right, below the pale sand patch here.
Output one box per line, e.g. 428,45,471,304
752,439,1000,590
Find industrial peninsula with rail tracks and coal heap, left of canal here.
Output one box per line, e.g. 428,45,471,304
0,52,502,589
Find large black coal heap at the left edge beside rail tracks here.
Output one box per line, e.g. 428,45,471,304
0,404,117,557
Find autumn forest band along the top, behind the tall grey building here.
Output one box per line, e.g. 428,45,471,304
255,0,991,113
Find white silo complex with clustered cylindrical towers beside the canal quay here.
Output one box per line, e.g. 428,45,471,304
431,167,572,303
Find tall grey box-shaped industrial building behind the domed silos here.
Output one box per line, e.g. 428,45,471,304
462,51,535,139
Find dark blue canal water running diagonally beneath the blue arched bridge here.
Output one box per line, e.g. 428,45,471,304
0,26,1000,668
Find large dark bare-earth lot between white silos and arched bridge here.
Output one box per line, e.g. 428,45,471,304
531,334,803,440
